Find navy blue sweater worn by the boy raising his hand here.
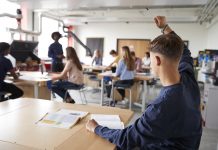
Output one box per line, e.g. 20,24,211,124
95,32,202,150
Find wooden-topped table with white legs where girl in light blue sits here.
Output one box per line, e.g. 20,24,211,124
98,71,153,112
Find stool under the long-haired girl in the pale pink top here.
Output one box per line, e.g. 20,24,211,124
64,84,87,104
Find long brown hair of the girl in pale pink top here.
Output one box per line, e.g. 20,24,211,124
66,47,82,70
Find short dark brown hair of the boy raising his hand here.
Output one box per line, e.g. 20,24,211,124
150,34,184,61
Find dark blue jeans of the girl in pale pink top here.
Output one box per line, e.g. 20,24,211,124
51,81,82,99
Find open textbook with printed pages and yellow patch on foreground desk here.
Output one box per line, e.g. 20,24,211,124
36,109,88,129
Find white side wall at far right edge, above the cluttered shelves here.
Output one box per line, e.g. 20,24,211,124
207,21,218,49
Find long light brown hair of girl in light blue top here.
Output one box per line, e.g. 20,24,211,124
122,46,135,71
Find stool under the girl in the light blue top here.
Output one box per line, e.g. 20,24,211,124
112,83,134,110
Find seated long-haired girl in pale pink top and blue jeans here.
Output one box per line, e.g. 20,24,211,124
51,47,83,103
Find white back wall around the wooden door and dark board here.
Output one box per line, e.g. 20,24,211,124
75,23,207,64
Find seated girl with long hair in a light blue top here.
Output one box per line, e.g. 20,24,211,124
114,46,135,102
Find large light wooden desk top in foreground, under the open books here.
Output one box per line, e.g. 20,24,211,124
0,99,133,150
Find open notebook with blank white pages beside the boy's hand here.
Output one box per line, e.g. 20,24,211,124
91,114,124,129
